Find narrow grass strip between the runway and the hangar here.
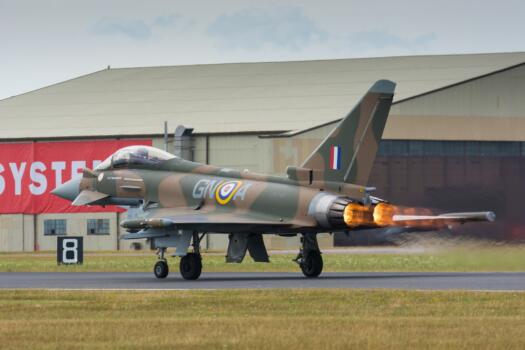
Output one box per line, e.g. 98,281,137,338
0,246,525,272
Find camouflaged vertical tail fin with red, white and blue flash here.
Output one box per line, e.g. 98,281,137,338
301,80,396,186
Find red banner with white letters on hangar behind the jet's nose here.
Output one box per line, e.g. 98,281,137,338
0,139,151,214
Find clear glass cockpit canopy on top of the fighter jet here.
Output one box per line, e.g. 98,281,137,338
95,146,176,170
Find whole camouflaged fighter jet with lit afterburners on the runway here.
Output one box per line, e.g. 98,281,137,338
53,80,495,280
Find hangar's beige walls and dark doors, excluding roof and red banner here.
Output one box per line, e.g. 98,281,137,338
0,56,525,251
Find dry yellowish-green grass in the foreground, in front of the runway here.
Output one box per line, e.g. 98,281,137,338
0,290,525,349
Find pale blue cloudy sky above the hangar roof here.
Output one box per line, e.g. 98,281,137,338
0,0,525,99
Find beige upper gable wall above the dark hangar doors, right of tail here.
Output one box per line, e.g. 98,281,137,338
383,64,525,141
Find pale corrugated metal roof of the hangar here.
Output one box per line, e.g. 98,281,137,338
0,52,525,139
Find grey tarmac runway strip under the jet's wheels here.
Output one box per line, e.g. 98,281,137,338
0,272,525,291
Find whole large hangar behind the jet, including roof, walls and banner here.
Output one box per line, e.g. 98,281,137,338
0,53,525,251
